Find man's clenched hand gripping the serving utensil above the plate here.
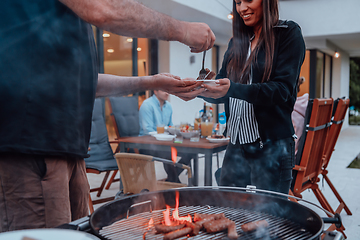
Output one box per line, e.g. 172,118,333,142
180,22,216,53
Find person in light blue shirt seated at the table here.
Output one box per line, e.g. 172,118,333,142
139,90,193,183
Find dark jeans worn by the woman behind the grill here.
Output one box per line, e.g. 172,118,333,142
220,138,295,194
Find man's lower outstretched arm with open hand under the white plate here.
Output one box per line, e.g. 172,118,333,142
96,73,204,100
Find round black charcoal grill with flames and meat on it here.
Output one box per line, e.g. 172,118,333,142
90,188,340,240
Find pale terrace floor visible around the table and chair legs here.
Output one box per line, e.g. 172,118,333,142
88,126,360,240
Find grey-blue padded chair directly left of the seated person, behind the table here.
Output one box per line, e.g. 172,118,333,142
105,95,140,189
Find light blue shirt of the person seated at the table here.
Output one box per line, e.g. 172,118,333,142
139,94,173,136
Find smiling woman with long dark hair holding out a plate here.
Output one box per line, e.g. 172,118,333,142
198,0,305,193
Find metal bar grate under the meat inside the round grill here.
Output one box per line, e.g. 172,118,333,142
99,206,312,240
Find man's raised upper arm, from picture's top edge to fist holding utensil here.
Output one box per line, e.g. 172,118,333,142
59,0,215,52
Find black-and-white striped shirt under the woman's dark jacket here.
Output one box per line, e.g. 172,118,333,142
227,44,260,145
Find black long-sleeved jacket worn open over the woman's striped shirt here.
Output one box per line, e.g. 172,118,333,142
204,21,306,141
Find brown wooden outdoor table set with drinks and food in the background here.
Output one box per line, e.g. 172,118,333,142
116,135,229,186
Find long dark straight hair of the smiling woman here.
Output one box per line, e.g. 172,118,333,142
227,0,279,83
